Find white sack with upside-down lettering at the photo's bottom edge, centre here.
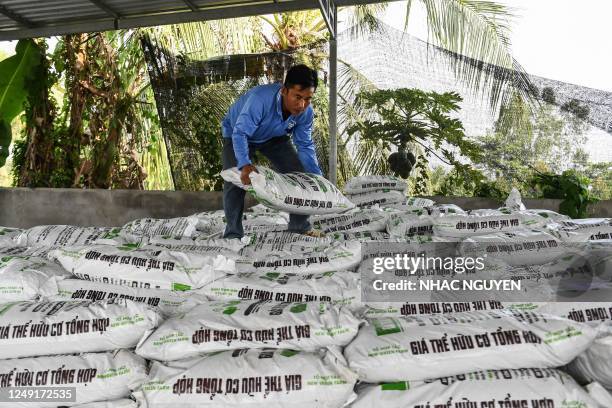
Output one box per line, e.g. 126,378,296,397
134,349,356,408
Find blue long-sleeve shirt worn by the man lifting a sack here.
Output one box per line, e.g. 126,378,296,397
221,83,322,174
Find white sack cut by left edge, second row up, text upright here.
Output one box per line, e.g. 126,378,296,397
0,300,160,359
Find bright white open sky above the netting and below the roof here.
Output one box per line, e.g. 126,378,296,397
0,0,612,92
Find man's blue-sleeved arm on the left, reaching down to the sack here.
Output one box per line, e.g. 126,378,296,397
232,94,264,169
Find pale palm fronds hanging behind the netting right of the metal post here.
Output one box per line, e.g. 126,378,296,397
339,0,534,180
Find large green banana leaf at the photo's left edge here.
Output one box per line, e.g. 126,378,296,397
0,40,44,167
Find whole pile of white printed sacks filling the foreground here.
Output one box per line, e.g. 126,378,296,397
0,169,612,408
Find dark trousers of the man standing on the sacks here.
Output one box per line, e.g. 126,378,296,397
222,136,311,238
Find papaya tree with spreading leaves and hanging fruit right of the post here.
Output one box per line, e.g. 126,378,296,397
347,88,479,178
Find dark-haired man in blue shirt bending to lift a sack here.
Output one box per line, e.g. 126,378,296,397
221,65,323,238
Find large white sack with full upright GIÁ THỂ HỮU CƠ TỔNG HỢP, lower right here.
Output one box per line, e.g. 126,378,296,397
344,310,596,382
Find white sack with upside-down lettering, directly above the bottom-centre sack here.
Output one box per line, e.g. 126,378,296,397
136,300,360,361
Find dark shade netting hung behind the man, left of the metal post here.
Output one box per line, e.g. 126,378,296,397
142,37,326,191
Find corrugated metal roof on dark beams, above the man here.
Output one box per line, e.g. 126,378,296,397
0,0,388,41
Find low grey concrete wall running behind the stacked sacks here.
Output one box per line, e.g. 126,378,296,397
0,188,612,228
